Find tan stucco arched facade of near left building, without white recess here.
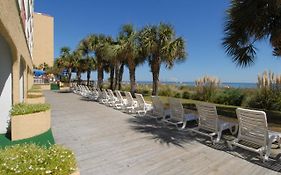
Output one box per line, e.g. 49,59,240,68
0,0,33,104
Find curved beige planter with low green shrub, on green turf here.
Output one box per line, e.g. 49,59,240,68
11,103,51,141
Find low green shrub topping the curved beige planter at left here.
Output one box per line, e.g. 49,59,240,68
10,103,51,116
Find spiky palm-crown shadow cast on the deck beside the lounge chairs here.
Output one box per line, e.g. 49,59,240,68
128,117,192,148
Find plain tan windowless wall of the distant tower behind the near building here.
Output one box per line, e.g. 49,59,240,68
33,13,54,66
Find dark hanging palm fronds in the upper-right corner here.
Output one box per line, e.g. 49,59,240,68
222,0,281,67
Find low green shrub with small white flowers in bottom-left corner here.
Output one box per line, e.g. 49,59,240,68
0,144,77,175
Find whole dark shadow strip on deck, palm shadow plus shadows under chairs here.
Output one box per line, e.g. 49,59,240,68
128,117,281,172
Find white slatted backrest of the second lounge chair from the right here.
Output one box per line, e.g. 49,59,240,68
196,103,219,132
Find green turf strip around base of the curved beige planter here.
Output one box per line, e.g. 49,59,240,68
0,129,55,149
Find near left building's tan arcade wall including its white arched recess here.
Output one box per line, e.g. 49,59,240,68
0,0,33,133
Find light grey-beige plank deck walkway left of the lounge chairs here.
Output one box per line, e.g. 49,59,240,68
45,91,281,175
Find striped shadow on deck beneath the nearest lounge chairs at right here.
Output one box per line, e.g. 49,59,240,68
193,131,281,172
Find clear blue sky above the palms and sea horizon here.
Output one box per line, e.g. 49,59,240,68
35,0,281,82
